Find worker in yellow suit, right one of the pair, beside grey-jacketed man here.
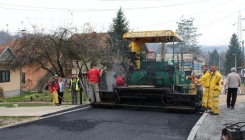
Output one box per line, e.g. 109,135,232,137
209,65,222,115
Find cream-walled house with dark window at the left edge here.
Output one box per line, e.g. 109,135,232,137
0,42,22,98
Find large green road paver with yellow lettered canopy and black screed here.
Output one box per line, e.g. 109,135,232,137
92,30,202,111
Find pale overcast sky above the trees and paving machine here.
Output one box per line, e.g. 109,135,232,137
0,0,245,46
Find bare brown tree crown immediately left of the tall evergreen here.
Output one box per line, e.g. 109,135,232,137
70,23,113,74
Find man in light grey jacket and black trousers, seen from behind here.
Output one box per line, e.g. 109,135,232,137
224,67,241,109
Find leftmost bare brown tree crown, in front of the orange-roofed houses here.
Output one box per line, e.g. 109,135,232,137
8,29,72,77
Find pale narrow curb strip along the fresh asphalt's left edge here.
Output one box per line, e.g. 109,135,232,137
0,105,91,129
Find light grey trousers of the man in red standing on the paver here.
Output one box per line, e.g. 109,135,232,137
89,82,100,102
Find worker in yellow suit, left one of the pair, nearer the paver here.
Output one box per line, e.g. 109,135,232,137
198,64,213,111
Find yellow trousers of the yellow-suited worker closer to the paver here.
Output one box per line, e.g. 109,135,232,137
202,87,213,109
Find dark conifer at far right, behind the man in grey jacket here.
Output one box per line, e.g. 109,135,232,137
224,34,243,74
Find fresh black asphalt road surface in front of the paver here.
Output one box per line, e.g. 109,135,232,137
0,106,202,140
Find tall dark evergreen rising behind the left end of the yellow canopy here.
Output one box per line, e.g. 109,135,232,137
106,7,129,54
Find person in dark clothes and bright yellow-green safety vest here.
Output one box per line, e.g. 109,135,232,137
69,74,81,105
